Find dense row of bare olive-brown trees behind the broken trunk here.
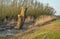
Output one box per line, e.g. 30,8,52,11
0,0,55,20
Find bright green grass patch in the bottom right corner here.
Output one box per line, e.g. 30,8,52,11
33,31,60,39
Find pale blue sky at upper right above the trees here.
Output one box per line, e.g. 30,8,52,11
38,0,60,15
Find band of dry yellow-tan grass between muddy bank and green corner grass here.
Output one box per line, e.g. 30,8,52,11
19,20,60,39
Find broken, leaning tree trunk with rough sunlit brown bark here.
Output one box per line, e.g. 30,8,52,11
15,7,27,29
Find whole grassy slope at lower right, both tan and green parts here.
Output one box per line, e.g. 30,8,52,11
19,19,60,39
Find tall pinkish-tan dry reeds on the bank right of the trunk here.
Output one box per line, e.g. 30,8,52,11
35,16,56,25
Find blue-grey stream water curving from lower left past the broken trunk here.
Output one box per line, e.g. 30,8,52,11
0,20,33,35
